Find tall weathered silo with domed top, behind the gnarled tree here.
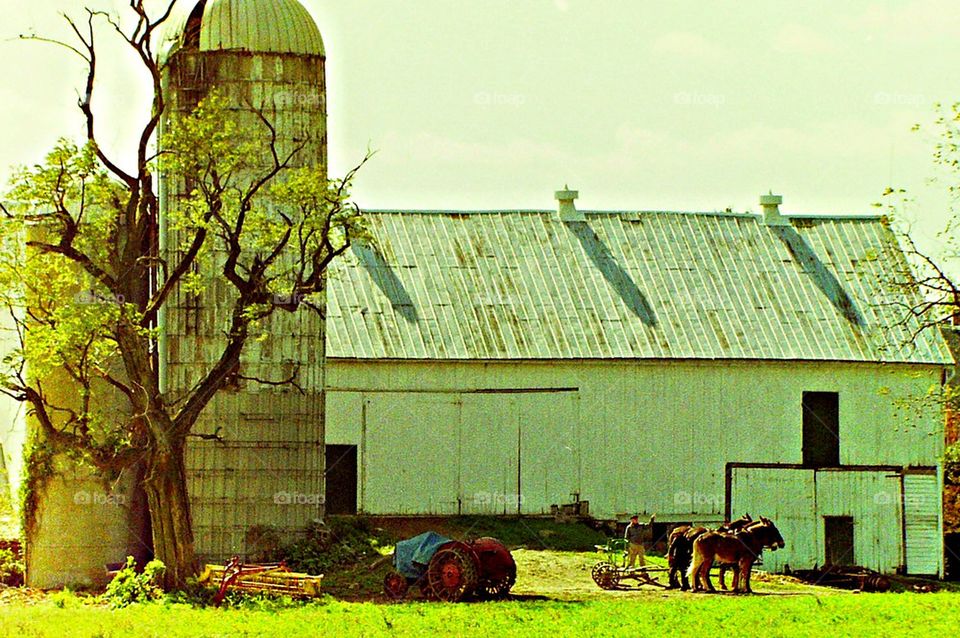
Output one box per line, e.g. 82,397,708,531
159,0,327,560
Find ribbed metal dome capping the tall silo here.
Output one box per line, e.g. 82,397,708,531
161,0,324,58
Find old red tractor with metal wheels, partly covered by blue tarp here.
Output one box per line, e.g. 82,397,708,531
383,532,517,602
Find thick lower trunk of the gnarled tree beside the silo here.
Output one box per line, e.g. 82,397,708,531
144,443,197,590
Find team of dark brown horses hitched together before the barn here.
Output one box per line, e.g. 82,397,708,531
667,514,784,593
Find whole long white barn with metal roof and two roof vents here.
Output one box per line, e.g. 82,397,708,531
310,192,952,574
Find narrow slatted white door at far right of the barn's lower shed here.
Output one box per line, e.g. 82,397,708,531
903,472,943,576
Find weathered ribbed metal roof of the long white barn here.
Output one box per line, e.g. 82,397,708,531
327,211,952,364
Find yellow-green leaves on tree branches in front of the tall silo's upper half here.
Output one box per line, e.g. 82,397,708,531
161,92,368,322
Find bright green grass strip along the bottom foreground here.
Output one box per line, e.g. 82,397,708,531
0,593,960,638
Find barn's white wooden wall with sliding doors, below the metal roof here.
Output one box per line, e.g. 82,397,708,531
326,361,942,521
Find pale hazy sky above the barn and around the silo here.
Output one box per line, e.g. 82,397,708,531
0,0,960,258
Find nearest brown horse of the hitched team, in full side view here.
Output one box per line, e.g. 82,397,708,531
687,516,784,593
